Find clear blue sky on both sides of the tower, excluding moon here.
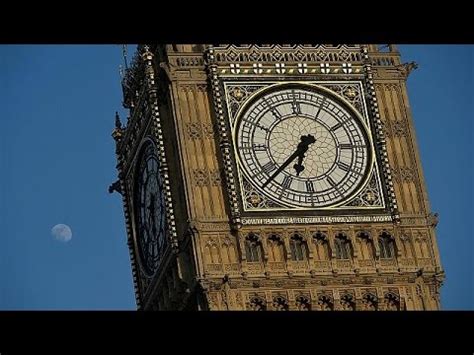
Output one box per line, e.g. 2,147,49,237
0,45,474,310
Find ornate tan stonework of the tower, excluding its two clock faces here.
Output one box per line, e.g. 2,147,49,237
113,45,444,310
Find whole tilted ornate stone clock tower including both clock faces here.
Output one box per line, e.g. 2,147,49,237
110,45,444,310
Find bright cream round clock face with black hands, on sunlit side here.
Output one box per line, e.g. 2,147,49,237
234,85,372,208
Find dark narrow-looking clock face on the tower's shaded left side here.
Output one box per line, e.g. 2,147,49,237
135,142,166,275
